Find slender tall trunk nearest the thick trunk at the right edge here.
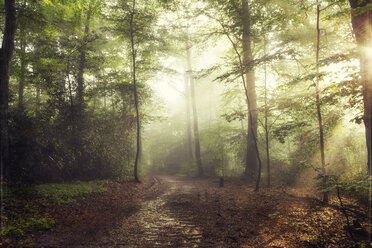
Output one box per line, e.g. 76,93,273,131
315,0,328,203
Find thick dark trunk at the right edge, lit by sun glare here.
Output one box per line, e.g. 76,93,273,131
349,0,372,176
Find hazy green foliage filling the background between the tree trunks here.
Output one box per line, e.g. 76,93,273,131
1,0,370,203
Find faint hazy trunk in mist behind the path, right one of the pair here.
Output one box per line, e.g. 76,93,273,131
186,34,204,177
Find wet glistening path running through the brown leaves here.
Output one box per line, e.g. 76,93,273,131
101,180,202,247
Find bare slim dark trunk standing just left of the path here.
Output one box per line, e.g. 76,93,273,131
130,0,141,182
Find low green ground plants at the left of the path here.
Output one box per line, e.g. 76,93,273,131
0,181,108,239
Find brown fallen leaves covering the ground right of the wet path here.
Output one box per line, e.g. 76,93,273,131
168,179,368,248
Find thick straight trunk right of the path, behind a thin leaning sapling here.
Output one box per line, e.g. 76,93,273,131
242,0,257,179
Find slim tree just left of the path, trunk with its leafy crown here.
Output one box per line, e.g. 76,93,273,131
110,0,164,182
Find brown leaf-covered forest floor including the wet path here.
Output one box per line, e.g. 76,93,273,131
4,176,370,248
